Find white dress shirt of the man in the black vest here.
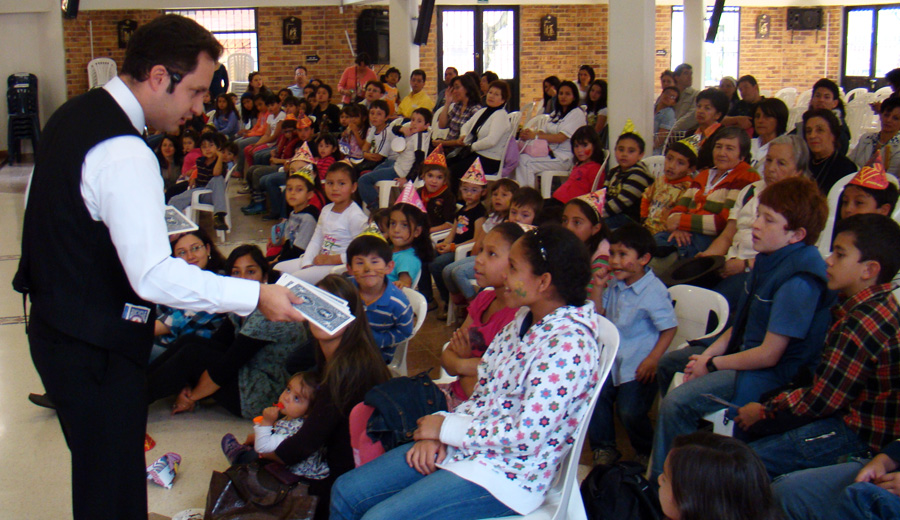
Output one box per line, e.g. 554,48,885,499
75,78,259,315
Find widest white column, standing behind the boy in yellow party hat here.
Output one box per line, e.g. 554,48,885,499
609,0,656,154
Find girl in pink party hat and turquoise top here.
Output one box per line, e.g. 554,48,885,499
388,181,434,288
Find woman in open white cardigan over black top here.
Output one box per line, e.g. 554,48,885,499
447,80,512,193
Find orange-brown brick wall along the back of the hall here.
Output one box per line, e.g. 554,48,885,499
63,5,842,107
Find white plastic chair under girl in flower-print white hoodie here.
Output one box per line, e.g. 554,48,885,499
482,317,619,520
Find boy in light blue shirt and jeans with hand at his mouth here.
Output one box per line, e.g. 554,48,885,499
588,223,678,464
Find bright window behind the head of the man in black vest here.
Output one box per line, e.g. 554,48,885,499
166,9,259,73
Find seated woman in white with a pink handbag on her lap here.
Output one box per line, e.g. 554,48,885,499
516,81,587,186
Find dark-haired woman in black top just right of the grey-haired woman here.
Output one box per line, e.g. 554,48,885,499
803,108,857,195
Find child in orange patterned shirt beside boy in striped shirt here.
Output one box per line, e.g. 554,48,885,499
641,139,697,235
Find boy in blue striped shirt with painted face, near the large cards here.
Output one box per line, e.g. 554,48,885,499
347,232,415,363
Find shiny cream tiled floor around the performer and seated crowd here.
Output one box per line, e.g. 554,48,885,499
0,167,622,520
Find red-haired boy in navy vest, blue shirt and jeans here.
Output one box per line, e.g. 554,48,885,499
652,177,835,475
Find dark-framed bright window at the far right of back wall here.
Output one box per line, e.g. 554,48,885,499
841,4,900,88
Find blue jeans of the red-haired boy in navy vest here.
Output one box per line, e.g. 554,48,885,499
650,360,740,482
